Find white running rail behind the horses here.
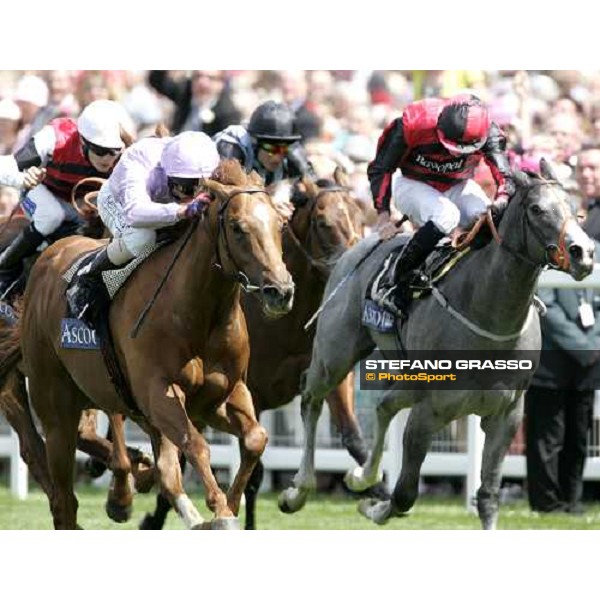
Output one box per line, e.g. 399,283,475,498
0,264,600,509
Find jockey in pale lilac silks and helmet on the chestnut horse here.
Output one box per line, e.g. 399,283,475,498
67,131,219,316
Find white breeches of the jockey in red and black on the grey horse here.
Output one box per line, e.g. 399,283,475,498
392,176,491,234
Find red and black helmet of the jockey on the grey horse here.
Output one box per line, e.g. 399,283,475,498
437,94,490,154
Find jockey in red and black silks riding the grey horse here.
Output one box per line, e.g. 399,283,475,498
367,94,513,315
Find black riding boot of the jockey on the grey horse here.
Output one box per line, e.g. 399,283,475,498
371,221,446,316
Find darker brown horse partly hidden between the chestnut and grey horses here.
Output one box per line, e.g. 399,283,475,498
141,169,375,529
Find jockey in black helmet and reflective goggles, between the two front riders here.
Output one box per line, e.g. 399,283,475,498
214,100,316,185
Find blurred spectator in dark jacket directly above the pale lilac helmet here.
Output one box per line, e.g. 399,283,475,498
148,71,242,136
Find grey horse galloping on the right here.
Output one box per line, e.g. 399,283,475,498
279,160,594,529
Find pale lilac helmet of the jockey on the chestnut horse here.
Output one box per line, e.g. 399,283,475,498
160,131,219,179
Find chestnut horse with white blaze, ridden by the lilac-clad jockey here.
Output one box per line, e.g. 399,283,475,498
1,161,293,528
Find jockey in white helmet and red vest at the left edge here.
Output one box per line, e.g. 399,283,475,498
0,100,126,300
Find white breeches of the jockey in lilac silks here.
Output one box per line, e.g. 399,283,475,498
98,183,156,265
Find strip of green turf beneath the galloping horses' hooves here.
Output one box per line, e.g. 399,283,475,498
0,486,600,530
